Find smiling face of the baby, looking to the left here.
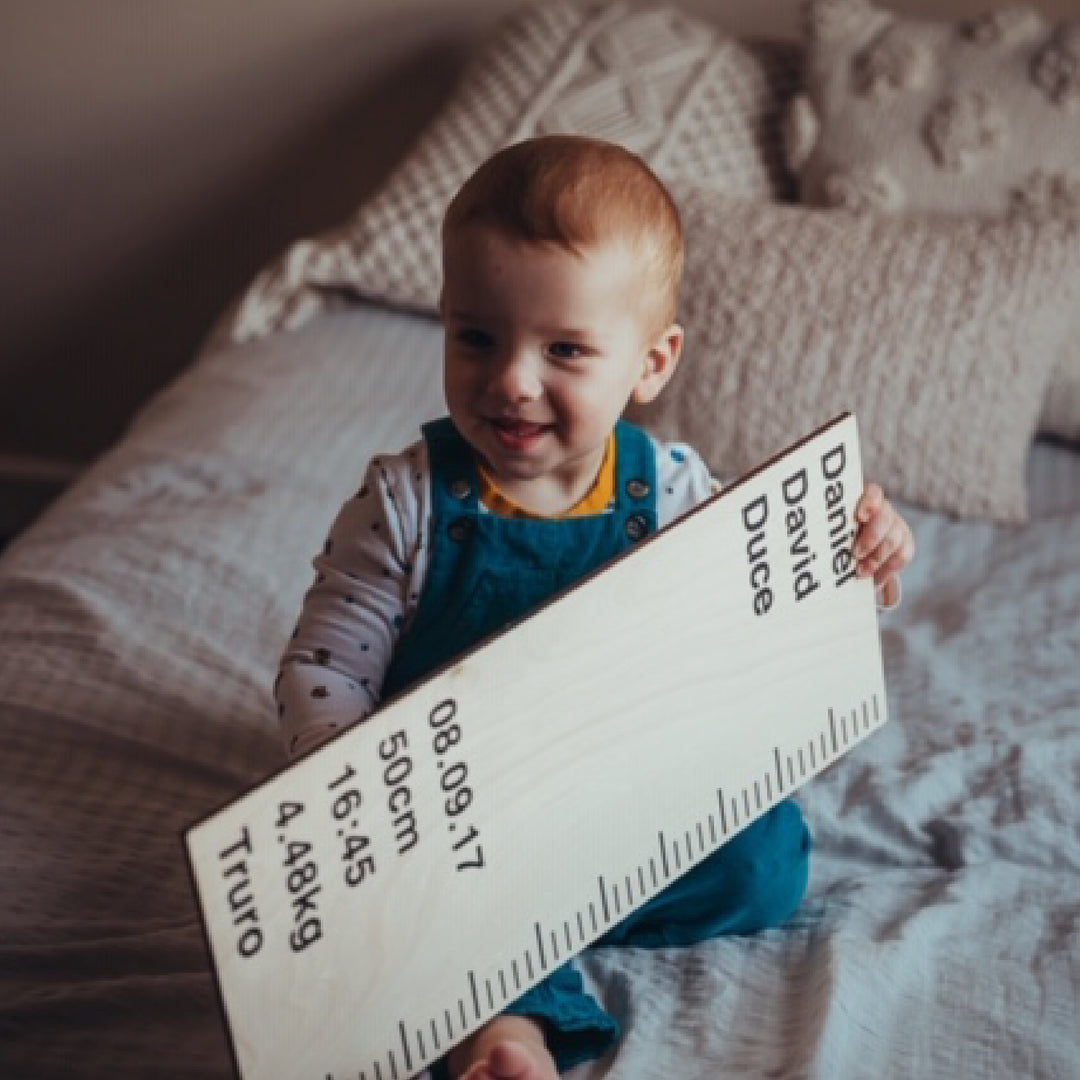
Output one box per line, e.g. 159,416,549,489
442,226,677,509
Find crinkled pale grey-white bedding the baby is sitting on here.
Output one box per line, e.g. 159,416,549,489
0,308,1080,1080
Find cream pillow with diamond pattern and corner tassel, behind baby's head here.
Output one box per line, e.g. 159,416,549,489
219,0,798,343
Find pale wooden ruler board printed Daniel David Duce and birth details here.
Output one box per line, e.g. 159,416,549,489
185,414,886,1080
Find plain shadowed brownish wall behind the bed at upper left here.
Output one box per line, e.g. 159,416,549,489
0,0,505,472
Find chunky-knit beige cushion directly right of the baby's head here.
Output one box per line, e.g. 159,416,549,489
632,185,1080,522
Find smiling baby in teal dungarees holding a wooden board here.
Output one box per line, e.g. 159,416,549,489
275,136,914,1080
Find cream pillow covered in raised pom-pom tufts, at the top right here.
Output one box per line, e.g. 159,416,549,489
785,0,1080,438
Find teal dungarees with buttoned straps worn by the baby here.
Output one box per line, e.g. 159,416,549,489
382,418,810,1080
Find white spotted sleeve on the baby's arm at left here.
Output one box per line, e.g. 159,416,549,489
274,444,428,757
